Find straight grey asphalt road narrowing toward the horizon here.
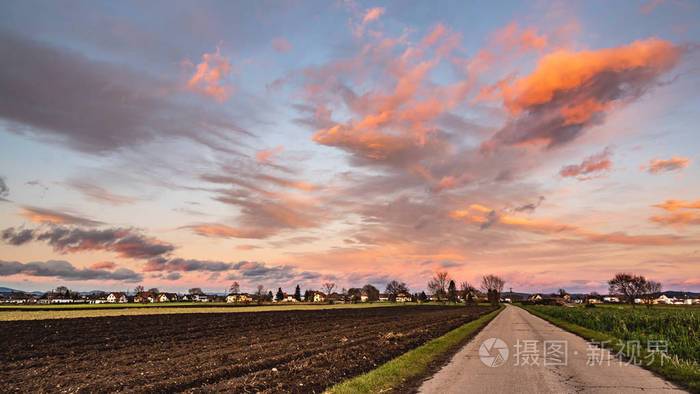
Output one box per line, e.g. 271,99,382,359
419,305,685,393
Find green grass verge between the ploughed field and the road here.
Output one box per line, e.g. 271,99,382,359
325,305,505,394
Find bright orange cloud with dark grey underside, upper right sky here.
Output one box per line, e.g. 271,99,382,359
482,38,683,151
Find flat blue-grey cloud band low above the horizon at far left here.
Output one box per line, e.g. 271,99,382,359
0,260,143,283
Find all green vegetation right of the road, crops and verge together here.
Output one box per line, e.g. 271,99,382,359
523,305,700,393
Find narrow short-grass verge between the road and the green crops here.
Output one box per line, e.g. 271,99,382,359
518,305,700,393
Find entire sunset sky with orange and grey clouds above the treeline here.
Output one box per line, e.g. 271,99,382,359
0,0,700,292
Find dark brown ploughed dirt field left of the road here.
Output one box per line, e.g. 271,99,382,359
0,306,494,392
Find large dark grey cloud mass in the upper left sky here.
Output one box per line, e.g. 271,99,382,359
0,30,245,154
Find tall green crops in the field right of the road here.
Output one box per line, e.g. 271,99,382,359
528,305,700,363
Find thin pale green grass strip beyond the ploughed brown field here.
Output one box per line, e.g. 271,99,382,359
0,302,410,321
